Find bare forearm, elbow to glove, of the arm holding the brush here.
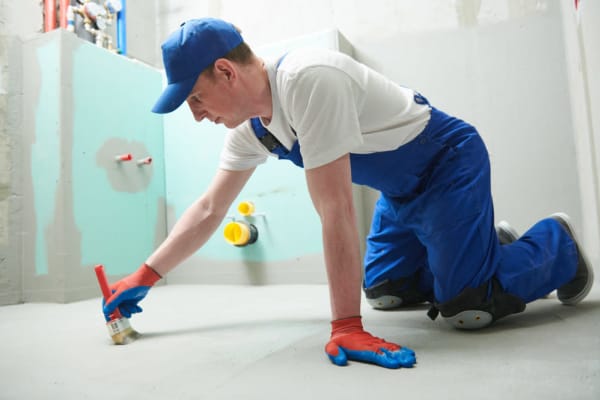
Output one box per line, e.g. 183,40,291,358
146,198,223,276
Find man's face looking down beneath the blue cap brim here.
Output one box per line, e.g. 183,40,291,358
186,62,247,128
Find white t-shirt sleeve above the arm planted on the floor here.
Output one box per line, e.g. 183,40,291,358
285,66,363,169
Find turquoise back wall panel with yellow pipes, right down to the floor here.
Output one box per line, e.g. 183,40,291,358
165,30,351,283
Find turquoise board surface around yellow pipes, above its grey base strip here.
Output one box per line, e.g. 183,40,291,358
164,32,346,262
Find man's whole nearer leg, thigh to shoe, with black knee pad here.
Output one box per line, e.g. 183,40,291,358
417,130,593,329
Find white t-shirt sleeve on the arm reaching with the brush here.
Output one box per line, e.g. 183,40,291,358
219,121,269,171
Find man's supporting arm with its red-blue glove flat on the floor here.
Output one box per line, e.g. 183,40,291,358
306,154,416,368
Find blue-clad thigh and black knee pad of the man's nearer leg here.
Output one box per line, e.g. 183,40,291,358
409,131,528,329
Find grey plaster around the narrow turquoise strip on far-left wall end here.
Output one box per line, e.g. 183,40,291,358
21,31,96,302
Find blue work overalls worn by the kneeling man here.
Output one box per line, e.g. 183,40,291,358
251,90,577,315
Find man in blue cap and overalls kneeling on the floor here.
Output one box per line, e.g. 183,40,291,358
104,18,593,368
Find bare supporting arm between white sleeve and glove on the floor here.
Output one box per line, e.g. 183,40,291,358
306,155,362,320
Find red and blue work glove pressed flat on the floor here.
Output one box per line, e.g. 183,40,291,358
325,317,417,368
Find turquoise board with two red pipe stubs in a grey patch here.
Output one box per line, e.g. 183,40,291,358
72,45,165,274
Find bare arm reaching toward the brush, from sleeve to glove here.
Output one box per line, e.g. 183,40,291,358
146,168,254,276
